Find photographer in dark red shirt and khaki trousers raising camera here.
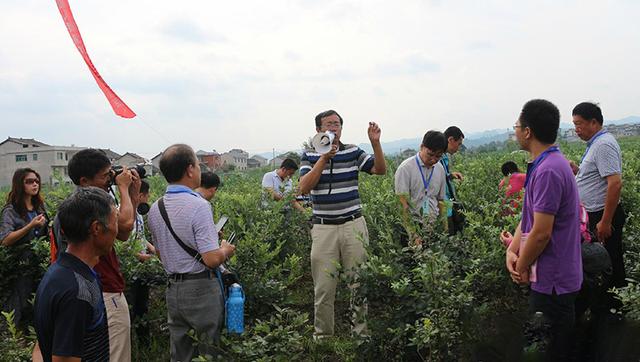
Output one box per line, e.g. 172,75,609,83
53,148,140,362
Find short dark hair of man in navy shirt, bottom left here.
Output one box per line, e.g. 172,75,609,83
58,187,114,243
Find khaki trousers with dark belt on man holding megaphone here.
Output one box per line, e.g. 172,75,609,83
311,217,369,337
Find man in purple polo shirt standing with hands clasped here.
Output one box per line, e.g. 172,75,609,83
506,99,582,361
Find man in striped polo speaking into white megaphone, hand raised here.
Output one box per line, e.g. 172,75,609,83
299,110,387,338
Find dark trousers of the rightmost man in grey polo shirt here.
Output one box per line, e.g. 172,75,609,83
588,205,627,307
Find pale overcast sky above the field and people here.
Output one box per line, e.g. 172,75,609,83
0,0,640,157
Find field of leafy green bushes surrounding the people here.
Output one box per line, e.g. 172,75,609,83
0,138,640,361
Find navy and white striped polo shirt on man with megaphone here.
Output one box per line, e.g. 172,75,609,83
300,143,374,219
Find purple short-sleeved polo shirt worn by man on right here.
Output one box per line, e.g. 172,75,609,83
521,151,582,295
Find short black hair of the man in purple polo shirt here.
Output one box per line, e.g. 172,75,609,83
520,99,560,144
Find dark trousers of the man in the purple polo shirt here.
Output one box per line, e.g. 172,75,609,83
529,290,578,361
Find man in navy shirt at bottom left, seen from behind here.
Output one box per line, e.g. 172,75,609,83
35,187,118,361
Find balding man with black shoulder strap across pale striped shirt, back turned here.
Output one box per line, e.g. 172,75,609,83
148,144,235,361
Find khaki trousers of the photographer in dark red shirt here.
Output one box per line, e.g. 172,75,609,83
102,293,131,362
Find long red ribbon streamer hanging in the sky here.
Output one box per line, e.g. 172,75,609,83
56,0,136,118
